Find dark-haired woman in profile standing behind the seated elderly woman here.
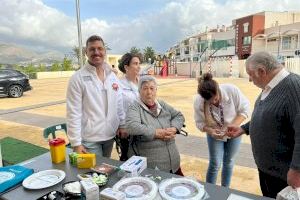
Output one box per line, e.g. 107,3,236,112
118,53,142,161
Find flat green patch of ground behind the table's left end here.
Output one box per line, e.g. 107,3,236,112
0,137,49,166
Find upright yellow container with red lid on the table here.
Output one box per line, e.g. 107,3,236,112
49,138,66,163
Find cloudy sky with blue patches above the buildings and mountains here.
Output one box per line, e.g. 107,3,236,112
0,0,300,54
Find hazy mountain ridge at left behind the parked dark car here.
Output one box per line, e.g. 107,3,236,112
0,43,64,65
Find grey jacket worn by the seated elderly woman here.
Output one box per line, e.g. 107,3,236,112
126,101,184,173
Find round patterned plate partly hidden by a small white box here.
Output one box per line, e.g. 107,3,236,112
113,177,158,200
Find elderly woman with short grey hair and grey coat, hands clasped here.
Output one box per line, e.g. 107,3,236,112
126,76,184,176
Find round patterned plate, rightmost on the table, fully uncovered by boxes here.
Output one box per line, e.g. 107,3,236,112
159,178,205,200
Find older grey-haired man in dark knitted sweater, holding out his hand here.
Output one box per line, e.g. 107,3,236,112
227,52,300,198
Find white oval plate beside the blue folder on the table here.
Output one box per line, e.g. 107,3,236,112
22,169,66,190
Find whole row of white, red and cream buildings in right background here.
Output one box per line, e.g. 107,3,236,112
167,11,300,62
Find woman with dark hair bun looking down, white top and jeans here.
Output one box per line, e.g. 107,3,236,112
194,73,249,187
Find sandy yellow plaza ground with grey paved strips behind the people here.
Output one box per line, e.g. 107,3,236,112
0,76,260,194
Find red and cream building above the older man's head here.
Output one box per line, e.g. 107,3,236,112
236,11,300,59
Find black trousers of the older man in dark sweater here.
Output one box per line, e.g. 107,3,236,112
258,170,288,199
